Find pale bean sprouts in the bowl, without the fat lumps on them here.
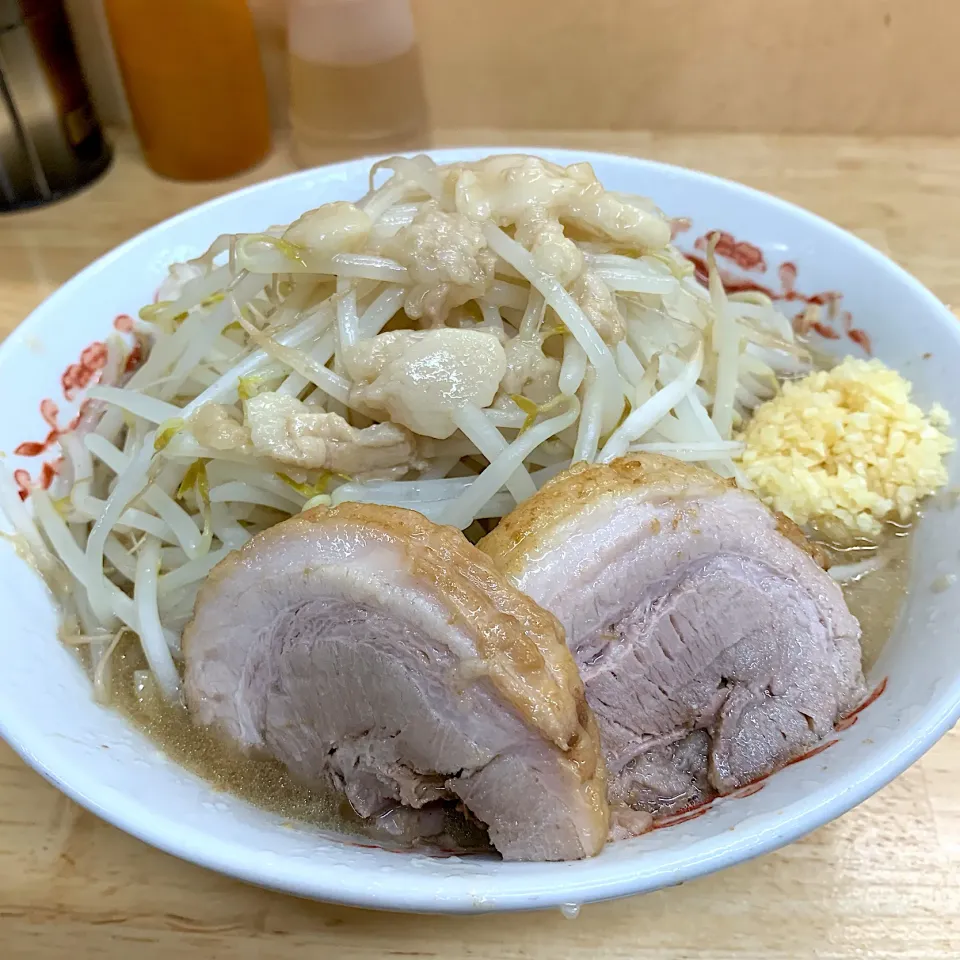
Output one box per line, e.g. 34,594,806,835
0,157,810,701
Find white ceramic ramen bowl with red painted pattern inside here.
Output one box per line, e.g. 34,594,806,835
0,150,960,912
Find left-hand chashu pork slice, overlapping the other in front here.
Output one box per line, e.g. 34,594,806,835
184,504,609,860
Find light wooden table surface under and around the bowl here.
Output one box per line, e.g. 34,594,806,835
0,131,960,960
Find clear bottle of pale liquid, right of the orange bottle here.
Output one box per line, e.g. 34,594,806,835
287,0,429,166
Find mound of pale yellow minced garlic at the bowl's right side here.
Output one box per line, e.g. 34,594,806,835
740,358,955,536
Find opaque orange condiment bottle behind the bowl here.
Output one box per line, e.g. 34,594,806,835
105,0,270,180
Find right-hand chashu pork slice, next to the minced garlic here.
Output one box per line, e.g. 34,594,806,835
480,454,864,822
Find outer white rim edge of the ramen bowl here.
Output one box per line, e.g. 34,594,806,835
0,146,960,913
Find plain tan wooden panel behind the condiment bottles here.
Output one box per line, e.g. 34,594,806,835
68,0,960,135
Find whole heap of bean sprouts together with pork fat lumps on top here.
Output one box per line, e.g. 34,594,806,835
0,157,808,699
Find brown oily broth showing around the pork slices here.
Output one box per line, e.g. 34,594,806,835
111,524,911,836
